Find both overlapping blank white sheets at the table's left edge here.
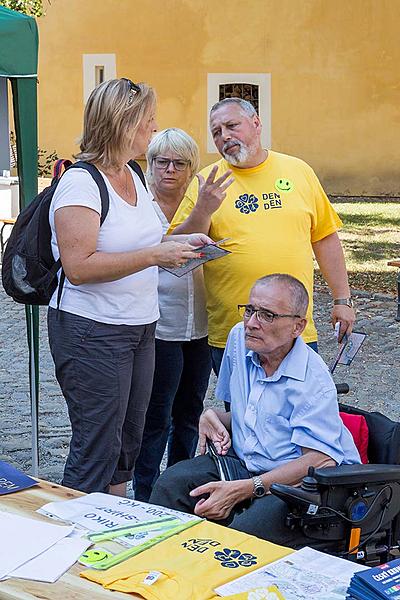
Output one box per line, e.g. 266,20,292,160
0,512,89,582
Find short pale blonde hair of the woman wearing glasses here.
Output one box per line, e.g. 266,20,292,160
146,127,200,183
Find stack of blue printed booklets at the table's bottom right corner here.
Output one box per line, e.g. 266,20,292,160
347,558,400,600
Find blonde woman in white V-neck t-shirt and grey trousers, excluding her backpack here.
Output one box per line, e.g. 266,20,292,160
48,79,208,495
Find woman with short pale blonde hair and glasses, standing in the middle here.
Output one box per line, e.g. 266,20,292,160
133,128,211,501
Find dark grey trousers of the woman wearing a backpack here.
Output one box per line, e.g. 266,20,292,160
48,308,155,492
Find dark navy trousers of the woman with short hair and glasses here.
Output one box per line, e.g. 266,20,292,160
133,337,211,502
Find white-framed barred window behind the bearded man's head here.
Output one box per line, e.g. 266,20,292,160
206,73,271,153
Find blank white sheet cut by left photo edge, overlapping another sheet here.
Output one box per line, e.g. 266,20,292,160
0,511,73,579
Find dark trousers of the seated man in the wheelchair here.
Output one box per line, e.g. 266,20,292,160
150,454,309,548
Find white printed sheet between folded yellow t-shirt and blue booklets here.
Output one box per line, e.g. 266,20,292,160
215,547,369,600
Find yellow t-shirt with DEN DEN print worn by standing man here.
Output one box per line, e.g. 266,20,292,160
170,151,342,348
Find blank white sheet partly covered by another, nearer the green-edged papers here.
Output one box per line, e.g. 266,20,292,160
8,536,91,583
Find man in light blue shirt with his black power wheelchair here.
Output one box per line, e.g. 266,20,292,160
150,274,388,556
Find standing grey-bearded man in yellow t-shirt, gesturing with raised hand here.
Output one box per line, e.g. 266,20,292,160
171,98,355,373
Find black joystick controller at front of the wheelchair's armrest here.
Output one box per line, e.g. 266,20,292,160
270,467,321,514
